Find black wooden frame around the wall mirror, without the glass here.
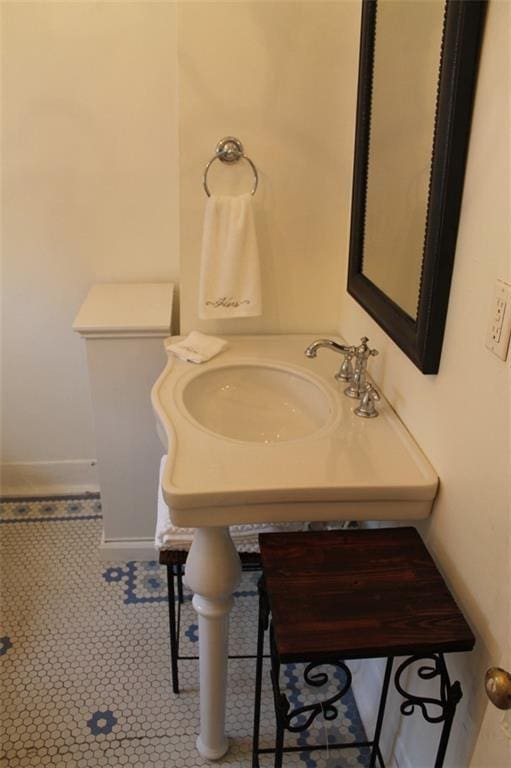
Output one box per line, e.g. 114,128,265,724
348,0,486,373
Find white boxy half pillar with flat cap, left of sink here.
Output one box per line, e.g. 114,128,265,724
73,283,174,561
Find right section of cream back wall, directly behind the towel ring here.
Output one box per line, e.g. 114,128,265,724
178,2,360,333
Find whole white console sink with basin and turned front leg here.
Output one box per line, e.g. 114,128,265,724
152,335,438,759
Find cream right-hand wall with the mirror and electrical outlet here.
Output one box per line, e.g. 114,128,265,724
340,2,511,768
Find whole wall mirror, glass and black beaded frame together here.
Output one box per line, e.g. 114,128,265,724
348,0,486,373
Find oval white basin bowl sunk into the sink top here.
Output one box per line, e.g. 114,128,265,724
182,363,336,444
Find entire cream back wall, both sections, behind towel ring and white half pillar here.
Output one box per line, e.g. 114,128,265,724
2,0,360,485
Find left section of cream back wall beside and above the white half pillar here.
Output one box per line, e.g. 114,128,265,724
1,2,179,492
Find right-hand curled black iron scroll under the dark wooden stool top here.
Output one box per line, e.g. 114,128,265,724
394,654,462,723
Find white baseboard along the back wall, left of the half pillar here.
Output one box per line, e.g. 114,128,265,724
0,459,99,498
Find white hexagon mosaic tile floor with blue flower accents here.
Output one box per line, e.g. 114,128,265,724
0,497,367,768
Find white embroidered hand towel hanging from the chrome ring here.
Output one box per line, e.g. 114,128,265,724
199,194,262,320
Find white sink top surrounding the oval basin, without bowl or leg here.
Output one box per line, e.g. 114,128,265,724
152,334,438,527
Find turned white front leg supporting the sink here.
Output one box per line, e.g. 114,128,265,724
185,527,241,760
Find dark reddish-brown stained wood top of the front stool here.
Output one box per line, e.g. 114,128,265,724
259,528,475,662
